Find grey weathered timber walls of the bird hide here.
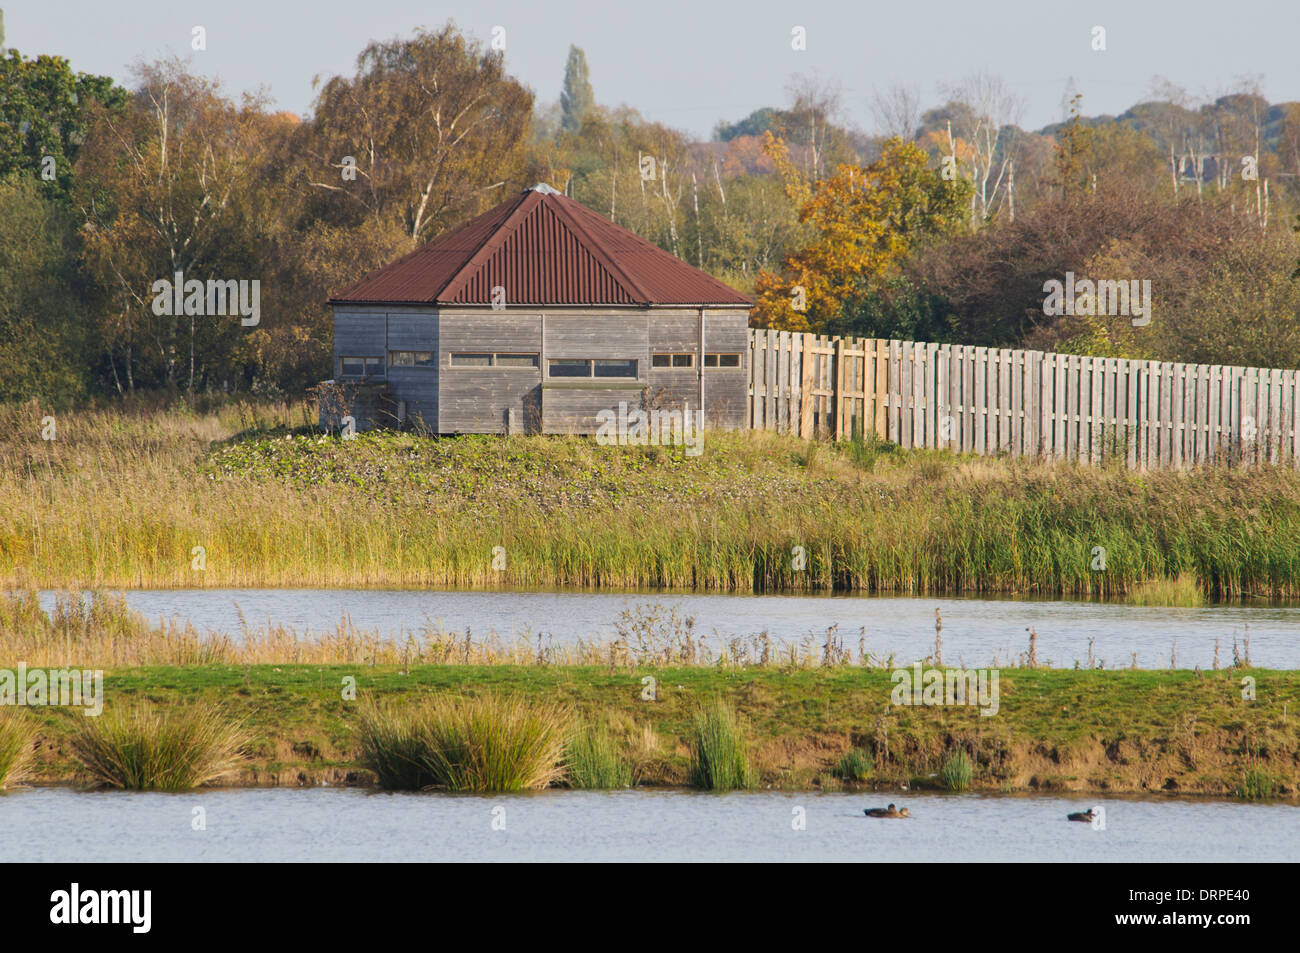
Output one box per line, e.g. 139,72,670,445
334,306,749,433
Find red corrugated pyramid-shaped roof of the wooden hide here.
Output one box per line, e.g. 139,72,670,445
330,186,753,307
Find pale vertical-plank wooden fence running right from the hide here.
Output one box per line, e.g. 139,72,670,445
749,329,1300,468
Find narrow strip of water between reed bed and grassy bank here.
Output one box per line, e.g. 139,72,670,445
42,589,1300,668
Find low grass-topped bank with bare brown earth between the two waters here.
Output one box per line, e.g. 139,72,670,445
12,664,1300,800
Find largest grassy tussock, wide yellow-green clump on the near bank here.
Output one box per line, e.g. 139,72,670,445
359,694,571,792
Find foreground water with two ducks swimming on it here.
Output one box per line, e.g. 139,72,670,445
0,788,1300,862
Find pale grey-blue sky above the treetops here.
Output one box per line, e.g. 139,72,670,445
10,0,1300,138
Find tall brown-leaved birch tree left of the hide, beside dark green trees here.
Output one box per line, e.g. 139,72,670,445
74,60,265,390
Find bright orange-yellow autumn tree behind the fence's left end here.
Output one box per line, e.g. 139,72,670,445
754,133,971,332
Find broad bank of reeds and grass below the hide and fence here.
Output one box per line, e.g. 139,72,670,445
0,395,1300,602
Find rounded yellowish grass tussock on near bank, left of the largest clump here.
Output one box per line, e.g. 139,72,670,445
70,706,247,790
